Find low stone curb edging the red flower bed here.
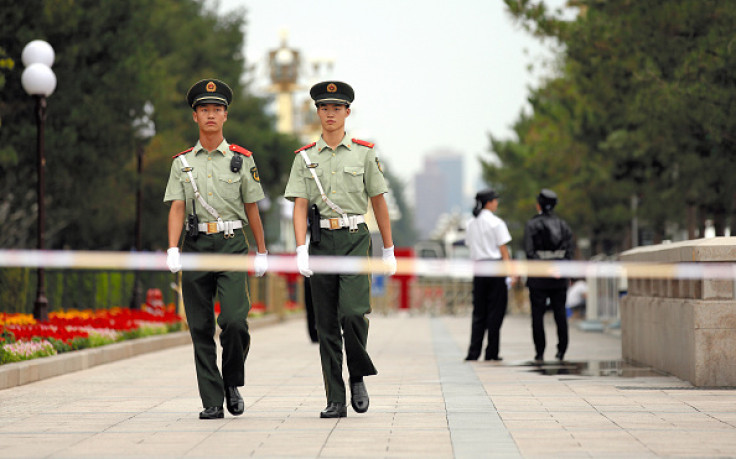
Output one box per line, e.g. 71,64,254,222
0,315,300,390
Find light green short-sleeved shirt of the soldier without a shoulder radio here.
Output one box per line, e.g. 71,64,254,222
284,135,388,218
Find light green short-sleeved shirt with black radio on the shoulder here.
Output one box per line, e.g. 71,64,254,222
164,140,264,223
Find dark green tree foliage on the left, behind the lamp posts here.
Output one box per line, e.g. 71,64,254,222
0,0,299,250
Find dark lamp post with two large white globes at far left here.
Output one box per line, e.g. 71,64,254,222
21,40,56,322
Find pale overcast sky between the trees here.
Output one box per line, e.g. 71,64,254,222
209,0,574,200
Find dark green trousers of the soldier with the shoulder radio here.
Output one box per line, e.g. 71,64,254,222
182,230,250,408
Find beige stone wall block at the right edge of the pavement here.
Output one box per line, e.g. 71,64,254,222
620,237,736,387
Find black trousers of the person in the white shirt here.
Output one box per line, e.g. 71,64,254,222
466,276,508,360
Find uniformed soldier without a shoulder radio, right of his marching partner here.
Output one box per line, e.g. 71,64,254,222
284,81,396,418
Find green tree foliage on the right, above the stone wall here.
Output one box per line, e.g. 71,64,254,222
492,0,736,252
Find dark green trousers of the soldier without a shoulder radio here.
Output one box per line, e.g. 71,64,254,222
309,224,378,403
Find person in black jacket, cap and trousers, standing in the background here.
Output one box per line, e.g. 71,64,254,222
524,189,573,361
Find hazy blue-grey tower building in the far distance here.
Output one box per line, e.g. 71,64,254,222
414,155,465,239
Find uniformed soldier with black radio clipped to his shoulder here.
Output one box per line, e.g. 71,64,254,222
164,79,268,419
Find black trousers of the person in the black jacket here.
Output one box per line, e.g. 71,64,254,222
529,287,568,357
